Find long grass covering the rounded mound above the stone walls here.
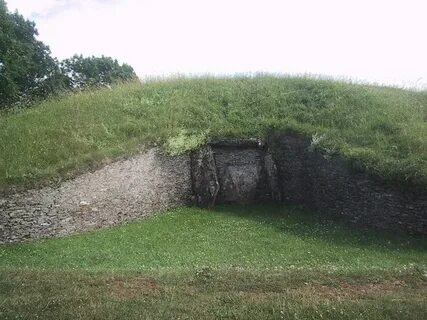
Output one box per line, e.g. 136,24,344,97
0,76,427,189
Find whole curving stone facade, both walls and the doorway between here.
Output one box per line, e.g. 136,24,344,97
0,133,427,243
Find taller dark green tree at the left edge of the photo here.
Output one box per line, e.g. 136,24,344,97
0,0,66,109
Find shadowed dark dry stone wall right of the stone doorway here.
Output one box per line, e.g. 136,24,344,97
269,134,427,234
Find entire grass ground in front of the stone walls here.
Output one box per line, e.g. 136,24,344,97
0,206,427,319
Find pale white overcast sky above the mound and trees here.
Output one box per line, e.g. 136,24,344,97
6,0,427,89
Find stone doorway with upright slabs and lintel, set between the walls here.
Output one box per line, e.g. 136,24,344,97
192,140,277,206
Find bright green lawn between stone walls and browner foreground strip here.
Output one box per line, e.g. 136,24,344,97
0,206,427,271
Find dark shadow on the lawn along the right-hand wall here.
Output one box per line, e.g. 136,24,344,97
210,204,427,253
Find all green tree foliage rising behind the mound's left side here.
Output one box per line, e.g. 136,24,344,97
0,0,136,109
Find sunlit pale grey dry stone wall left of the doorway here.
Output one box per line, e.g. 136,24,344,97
0,149,192,242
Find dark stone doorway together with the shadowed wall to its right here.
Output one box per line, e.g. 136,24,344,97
192,134,427,234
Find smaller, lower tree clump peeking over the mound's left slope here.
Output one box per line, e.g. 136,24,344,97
61,55,137,89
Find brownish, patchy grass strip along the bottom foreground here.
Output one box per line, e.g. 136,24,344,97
0,271,427,320
